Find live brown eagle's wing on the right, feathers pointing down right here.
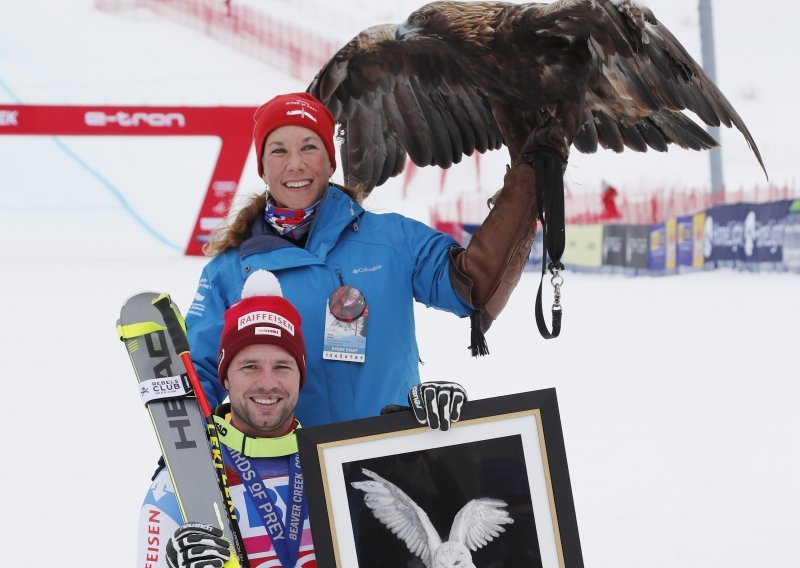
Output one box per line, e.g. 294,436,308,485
540,0,766,174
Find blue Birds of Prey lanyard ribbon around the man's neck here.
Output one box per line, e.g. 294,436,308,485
220,444,307,568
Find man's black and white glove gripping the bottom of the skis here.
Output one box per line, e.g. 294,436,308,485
167,523,231,568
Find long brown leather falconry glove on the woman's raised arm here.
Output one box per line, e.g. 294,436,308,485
450,132,538,356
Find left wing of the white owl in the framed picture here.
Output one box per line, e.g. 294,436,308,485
351,469,442,566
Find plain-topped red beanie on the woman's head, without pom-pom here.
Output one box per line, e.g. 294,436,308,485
253,93,336,177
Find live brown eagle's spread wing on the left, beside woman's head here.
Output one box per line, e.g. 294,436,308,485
308,24,503,196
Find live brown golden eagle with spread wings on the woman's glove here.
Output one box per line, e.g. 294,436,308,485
308,0,766,194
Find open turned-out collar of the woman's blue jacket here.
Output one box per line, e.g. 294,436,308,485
239,185,364,259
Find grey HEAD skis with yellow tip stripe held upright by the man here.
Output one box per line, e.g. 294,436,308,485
117,292,249,567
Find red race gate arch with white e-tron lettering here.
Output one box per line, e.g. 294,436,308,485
0,105,256,255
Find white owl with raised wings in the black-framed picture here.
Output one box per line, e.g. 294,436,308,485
352,469,514,568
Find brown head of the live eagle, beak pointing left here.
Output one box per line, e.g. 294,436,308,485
395,1,500,45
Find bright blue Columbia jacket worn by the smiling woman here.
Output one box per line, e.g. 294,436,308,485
186,186,472,426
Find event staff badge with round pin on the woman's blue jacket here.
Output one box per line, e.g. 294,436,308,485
322,286,369,363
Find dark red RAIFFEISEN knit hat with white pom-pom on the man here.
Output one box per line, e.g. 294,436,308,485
217,270,306,388
